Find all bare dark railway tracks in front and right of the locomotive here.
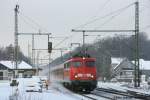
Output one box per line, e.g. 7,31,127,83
76,88,150,100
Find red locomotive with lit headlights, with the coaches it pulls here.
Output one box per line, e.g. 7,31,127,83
51,57,97,91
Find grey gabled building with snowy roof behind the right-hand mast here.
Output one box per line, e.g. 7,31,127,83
112,58,150,82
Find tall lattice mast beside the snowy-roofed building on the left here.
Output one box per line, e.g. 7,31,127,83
14,5,19,78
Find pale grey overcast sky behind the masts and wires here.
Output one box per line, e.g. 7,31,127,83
0,0,150,61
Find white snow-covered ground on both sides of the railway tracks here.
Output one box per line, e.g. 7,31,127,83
0,78,150,100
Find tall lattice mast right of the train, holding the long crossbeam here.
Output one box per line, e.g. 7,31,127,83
134,1,140,87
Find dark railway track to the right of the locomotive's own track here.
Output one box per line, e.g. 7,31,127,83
91,88,150,100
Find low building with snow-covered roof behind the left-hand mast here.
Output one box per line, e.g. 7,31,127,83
0,61,36,80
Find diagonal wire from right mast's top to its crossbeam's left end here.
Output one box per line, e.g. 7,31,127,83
75,3,134,29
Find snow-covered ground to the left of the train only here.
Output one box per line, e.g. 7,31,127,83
0,78,100,100
